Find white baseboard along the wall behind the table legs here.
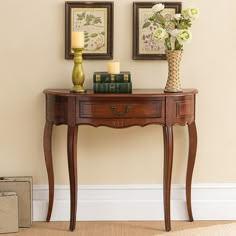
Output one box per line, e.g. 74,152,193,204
33,184,236,221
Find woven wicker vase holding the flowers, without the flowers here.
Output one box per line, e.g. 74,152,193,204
164,50,183,93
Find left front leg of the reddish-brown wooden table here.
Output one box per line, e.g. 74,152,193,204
67,126,78,231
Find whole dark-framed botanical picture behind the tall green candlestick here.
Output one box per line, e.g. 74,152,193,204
65,1,114,60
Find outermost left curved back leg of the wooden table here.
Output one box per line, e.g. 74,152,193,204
43,121,54,222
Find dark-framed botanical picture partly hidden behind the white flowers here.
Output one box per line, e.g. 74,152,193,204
133,2,182,60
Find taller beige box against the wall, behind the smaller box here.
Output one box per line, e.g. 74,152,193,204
0,176,33,227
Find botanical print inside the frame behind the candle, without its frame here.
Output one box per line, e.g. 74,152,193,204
71,8,107,53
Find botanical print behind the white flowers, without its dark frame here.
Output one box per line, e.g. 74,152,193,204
139,8,175,54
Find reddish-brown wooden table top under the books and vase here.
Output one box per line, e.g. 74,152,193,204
43,89,198,97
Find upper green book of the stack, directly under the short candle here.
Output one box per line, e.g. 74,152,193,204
93,71,131,83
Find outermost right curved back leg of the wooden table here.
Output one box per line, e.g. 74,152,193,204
186,121,197,221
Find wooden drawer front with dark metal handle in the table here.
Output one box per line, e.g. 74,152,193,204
79,100,164,118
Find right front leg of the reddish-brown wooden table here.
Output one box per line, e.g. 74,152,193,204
163,126,174,231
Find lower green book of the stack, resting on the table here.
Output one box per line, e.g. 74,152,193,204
93,82,132,93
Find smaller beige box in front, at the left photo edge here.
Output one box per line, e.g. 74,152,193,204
0,192,18,234
